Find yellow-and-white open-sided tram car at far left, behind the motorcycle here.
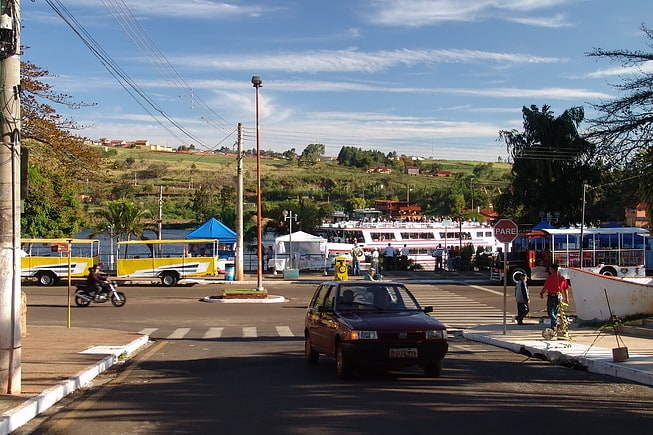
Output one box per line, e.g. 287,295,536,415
20,238,100,285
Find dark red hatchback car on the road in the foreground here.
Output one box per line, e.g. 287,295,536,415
304,281,449,378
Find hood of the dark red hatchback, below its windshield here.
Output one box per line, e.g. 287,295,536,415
341,311,446,331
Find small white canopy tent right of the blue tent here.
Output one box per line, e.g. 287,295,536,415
274,231,326,270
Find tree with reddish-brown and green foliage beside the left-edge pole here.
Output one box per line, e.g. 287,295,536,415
21,62,104,237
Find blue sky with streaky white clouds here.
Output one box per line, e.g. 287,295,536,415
21,0,653,161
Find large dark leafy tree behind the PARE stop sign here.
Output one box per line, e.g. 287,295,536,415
497,105,600,225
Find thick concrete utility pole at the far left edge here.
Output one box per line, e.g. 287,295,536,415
0,0,22,394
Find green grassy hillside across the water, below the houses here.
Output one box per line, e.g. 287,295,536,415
100,149,510,228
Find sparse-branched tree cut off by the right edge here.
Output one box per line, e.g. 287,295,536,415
586,24,653,220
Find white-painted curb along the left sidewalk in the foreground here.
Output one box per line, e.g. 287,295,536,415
0,335,150,435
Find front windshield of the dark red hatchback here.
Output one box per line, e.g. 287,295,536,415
336,284,421,311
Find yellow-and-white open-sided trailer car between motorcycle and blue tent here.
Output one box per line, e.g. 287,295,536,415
116,239,218,287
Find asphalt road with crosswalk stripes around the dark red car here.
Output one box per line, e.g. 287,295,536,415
16,284,653,435
